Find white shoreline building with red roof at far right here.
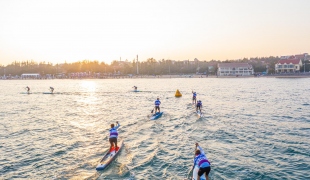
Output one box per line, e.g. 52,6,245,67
275,58,302,73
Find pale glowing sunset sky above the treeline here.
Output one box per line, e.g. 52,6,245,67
0,0,310,65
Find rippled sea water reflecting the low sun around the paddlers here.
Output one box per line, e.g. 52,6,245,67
0,78,310,180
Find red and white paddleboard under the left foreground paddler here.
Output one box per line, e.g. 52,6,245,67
96,141,124,171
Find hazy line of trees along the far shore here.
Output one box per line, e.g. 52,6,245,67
0,56,310,76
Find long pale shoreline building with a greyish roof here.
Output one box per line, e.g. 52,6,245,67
217,63,254,76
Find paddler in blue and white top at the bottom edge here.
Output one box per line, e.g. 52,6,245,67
194,143,211,180
